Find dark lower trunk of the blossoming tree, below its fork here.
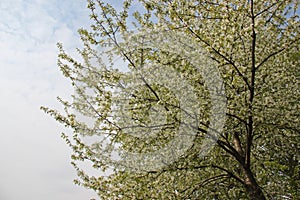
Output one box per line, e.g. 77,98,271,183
244,169,266,200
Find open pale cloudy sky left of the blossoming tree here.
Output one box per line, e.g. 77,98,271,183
0,0,101,200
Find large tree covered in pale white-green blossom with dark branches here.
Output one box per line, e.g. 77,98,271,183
42,0,300,200
